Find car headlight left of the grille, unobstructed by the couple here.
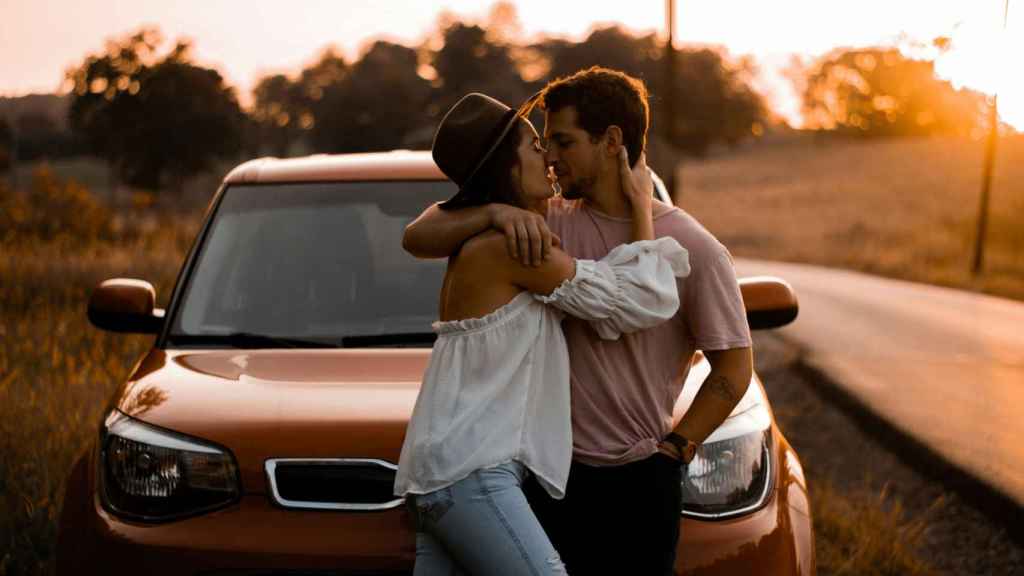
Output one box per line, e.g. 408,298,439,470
100,410,240,522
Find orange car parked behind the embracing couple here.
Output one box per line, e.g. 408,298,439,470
57,152,815,575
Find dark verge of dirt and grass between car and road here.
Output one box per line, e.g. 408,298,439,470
754,330,1024,576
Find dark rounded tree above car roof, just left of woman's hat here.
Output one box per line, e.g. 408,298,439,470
310,41,430,153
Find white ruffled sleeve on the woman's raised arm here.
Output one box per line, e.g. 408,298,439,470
534,237,690,340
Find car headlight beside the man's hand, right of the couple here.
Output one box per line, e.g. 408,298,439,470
682,428,772,520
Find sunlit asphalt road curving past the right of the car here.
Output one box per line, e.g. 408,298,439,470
736,259,1024,506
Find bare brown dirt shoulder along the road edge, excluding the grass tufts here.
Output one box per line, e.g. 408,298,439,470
755,333,1024,576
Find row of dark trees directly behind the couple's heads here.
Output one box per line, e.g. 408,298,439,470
276,15,766,154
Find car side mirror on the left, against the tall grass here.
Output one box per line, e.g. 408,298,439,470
87,278,164,334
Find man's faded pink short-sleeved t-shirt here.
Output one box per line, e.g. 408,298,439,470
548,194,751,466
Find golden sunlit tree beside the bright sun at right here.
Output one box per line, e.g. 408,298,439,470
803,48,987,136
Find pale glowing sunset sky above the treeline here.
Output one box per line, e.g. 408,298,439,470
0,0,1024,129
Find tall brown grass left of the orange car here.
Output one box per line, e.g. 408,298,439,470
0,169,200,575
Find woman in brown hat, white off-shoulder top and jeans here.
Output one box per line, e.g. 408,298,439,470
395,93,689,575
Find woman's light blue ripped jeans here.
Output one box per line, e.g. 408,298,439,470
409,461,565,576
